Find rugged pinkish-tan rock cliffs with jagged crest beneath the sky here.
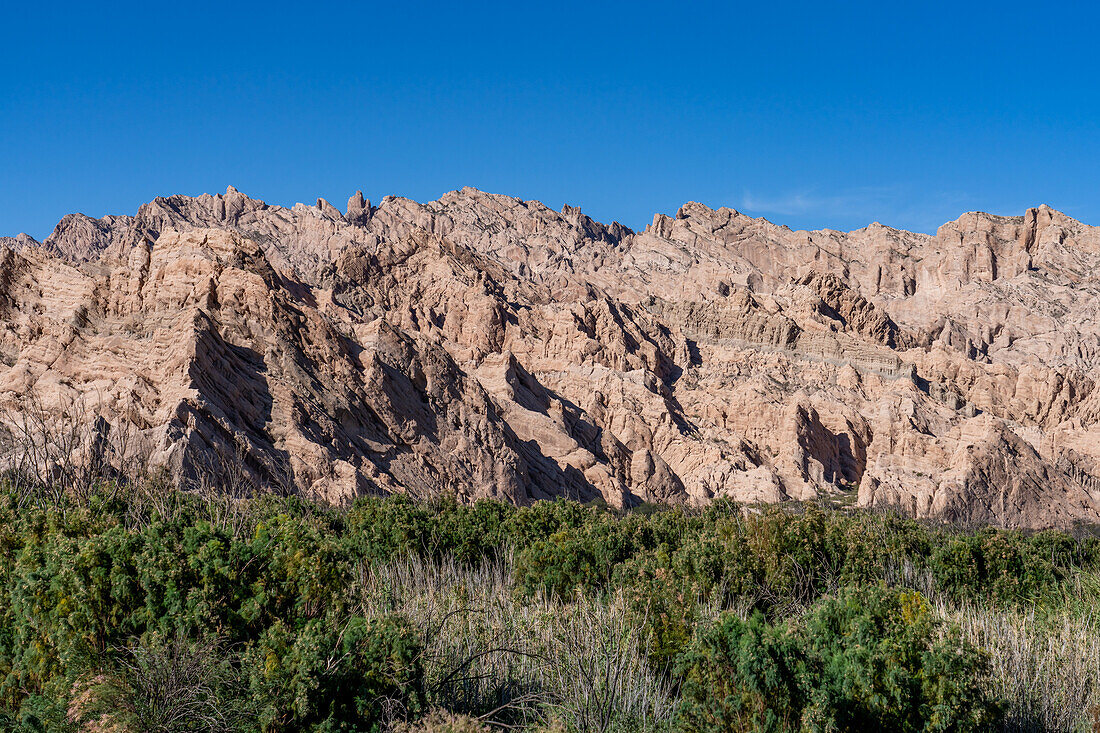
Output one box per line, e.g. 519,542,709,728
0,188,1100,527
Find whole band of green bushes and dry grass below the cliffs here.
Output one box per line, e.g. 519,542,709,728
0,462,1100,733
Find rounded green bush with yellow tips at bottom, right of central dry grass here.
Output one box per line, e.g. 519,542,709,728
680,588,1000,732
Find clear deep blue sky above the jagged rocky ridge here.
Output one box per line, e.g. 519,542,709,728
0,1,1100,239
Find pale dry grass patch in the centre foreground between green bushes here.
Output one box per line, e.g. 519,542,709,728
359,556,675,733
